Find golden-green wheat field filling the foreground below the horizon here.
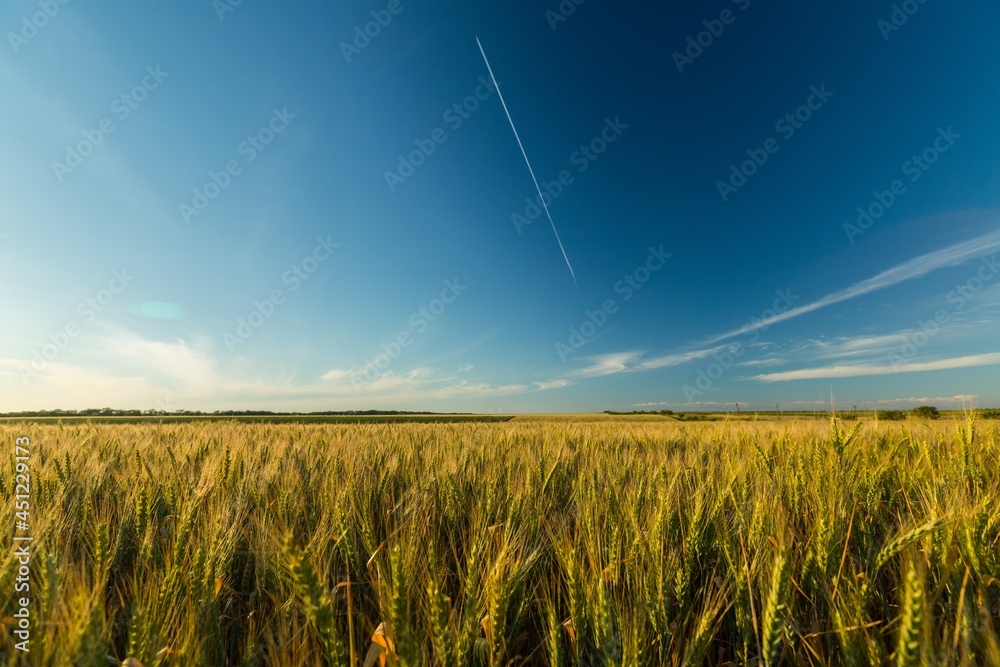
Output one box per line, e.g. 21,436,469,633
0,416,1000,667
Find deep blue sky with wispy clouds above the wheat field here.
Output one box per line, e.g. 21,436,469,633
0,0,1000,412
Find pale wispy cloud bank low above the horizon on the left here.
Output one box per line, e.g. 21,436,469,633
0,325,572,410
